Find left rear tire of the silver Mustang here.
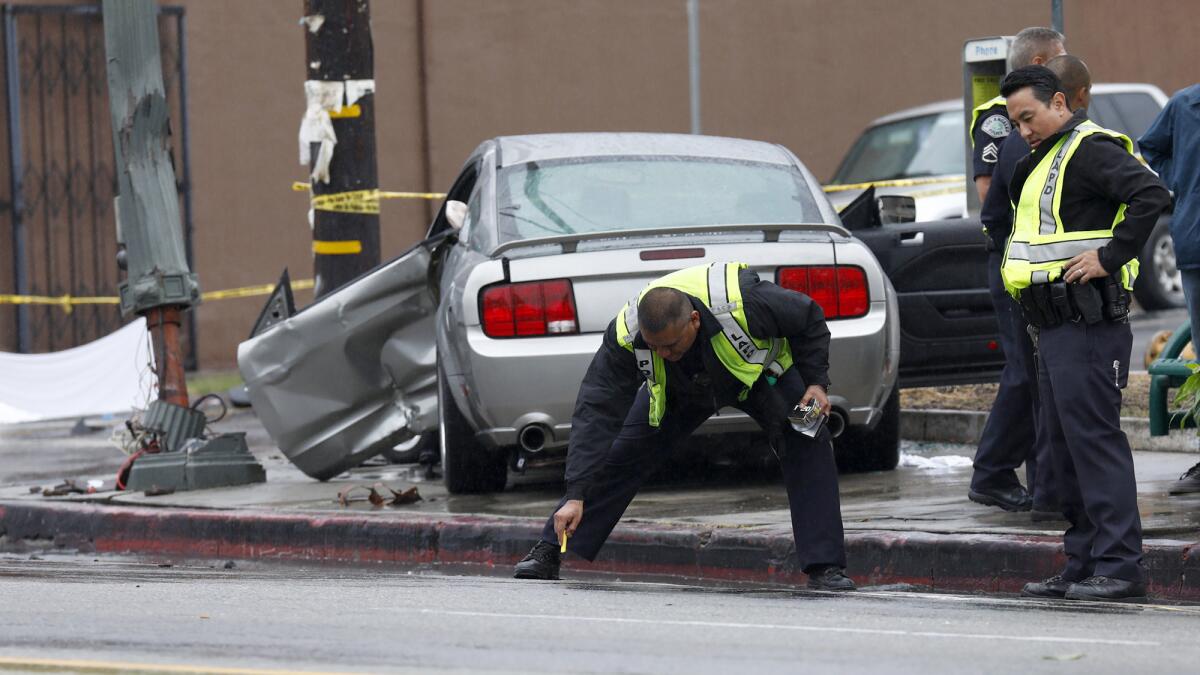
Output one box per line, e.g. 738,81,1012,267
438,368,509,495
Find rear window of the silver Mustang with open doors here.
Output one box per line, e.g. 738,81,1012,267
496,157,822,243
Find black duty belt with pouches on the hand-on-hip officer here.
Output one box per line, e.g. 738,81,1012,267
1018,275,1129,328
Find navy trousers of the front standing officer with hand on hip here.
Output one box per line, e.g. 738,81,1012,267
1038,321,1142,581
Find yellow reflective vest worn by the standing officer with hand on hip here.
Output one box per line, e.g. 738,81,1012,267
1000,120,1138,297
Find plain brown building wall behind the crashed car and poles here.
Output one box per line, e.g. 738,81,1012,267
0,0,1200,368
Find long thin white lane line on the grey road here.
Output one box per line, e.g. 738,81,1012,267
420,609,1162,647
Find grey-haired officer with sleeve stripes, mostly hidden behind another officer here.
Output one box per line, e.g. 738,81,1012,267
967,26,1066,511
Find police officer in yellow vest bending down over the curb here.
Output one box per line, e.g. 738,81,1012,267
515,263,854,591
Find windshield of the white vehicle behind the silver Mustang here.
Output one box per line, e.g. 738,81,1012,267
832,110,965,185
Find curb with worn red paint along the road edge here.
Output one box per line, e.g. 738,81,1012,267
0,502,1200,601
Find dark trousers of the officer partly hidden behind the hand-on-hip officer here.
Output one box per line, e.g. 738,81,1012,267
971,251,1058,502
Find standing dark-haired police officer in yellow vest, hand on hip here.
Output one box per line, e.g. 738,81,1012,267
1001,66,1170,601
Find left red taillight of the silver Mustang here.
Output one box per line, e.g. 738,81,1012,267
479,279,580,338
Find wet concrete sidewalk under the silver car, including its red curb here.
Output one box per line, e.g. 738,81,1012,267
0,403,1200,601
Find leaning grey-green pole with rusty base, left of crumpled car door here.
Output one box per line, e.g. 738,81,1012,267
103,0,200,407
